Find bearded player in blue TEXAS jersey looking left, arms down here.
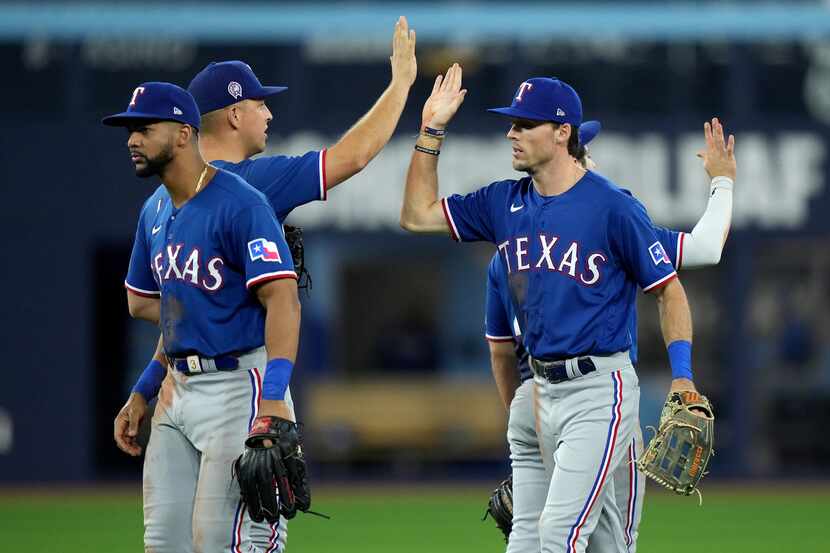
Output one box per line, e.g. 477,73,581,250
103,82,300,552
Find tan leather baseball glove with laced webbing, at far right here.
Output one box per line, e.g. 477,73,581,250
637,391,715,495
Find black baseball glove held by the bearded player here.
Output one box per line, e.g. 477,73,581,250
233,417,311,524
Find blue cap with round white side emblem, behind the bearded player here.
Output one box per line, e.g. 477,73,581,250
187,60,287,115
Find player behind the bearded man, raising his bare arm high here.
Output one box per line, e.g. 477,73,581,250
114,17,417,551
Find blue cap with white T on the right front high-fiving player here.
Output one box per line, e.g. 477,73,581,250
487,77,582,127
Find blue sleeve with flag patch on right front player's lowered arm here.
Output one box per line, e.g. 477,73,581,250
609,198,677,292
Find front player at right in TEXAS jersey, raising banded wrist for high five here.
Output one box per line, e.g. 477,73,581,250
401,64,716,553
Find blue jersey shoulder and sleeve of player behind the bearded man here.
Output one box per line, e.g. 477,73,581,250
211,150,327,223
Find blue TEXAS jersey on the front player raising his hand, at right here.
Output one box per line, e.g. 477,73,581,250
442,171,676,359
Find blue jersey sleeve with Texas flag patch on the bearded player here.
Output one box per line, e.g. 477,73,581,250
231,202,297,290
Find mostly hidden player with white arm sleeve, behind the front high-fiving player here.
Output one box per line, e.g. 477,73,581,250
485,119,736,553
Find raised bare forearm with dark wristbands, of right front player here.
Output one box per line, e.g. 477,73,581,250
401,135,449,233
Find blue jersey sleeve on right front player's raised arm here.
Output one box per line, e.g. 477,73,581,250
441,184,498,242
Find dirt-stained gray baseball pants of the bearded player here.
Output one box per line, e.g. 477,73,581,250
144,348,293,553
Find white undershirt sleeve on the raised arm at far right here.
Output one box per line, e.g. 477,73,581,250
681,177,734,269
